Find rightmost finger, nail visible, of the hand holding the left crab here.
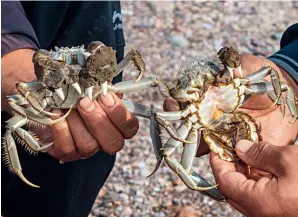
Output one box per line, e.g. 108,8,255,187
98,93,139,139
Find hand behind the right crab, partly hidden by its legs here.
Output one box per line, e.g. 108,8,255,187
164,54,298,160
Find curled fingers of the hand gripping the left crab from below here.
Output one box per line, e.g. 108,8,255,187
37,93,139,162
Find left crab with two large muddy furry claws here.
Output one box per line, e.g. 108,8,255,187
3,41,159,188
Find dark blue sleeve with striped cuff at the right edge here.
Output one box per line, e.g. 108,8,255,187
268,23,298,82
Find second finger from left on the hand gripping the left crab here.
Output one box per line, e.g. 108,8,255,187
67,111,100,159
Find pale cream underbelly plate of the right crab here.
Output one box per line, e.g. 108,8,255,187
198,84,241,127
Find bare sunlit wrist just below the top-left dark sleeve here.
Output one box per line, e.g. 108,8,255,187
1,49,36,112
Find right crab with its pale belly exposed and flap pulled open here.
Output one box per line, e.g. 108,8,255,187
143,47,298,201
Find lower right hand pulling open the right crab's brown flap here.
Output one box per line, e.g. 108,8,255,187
210,140,298,217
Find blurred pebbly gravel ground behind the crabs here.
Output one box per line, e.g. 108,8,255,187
89,2,298,217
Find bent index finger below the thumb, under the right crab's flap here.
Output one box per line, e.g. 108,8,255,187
210,152,255,204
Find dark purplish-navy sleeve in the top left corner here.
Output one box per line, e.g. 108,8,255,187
1,1,40,57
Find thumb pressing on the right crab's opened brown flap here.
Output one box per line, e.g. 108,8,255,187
236,140,286,176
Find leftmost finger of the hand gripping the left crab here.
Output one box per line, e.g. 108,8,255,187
48,109,76,161
